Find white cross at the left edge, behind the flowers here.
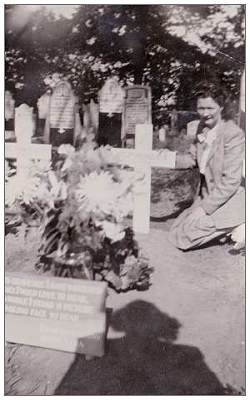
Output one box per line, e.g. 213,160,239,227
5,104,51,179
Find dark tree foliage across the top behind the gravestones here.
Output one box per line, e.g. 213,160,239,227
6,4,245,111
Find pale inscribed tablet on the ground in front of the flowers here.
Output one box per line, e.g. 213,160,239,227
5,272,107,356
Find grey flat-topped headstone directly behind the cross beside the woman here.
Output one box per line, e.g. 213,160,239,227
123,85,152,147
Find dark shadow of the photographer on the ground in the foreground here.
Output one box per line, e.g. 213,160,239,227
55,300,224,395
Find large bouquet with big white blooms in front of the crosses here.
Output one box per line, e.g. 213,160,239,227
6,143,152,291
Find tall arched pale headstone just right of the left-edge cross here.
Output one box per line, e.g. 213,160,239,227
49,80,76,146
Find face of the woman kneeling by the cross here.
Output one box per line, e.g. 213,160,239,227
197,97,223,128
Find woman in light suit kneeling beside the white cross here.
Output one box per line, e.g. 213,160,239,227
169,83,245,250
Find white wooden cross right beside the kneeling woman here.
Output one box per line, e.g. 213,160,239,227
110,124,175,233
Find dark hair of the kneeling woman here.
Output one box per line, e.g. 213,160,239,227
194,81,237,120
